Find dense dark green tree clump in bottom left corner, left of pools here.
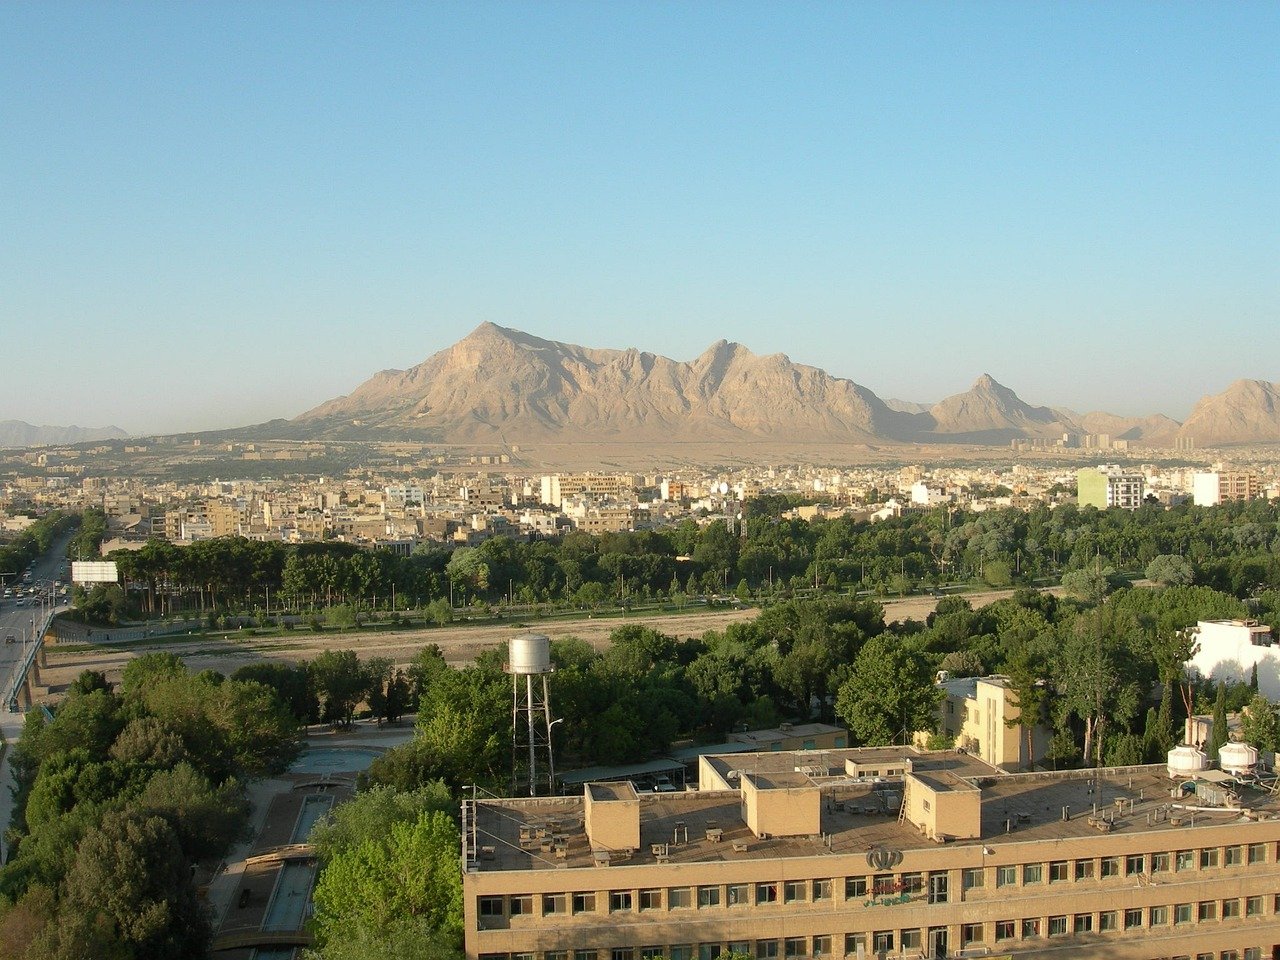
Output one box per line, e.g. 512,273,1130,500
0,654,300,960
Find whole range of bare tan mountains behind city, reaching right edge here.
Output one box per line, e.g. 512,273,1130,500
222,324,1280,445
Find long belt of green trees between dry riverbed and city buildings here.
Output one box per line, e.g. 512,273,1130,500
94,498,1280,616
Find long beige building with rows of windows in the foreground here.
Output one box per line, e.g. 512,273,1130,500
463,748,1280,960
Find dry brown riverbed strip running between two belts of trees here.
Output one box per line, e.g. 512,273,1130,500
41,588,1061,695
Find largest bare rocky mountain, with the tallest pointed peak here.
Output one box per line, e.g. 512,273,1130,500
293,324,914,443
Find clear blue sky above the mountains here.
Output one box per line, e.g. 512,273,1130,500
0,0,1280,433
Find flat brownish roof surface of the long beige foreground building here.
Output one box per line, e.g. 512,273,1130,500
476,748,1280,872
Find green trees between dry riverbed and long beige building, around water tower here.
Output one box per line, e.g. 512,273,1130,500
335,586,1251,792
